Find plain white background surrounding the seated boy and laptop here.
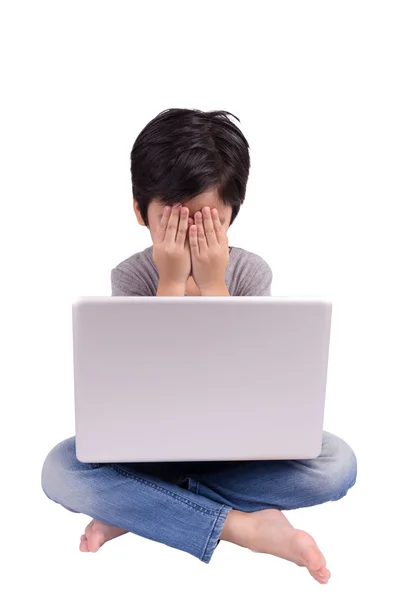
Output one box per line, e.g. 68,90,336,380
0,0,400,600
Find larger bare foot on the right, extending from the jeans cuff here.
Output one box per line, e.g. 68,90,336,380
221,509,331,583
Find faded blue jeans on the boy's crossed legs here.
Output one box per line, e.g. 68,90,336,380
42,432,357,563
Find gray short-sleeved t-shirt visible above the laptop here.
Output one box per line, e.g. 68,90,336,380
111,246,272,296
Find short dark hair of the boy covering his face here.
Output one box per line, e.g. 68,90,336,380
131,108,250,226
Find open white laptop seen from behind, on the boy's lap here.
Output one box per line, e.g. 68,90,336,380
73,296,332,463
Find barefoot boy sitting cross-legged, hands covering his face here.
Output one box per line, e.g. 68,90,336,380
42,109,357,583
